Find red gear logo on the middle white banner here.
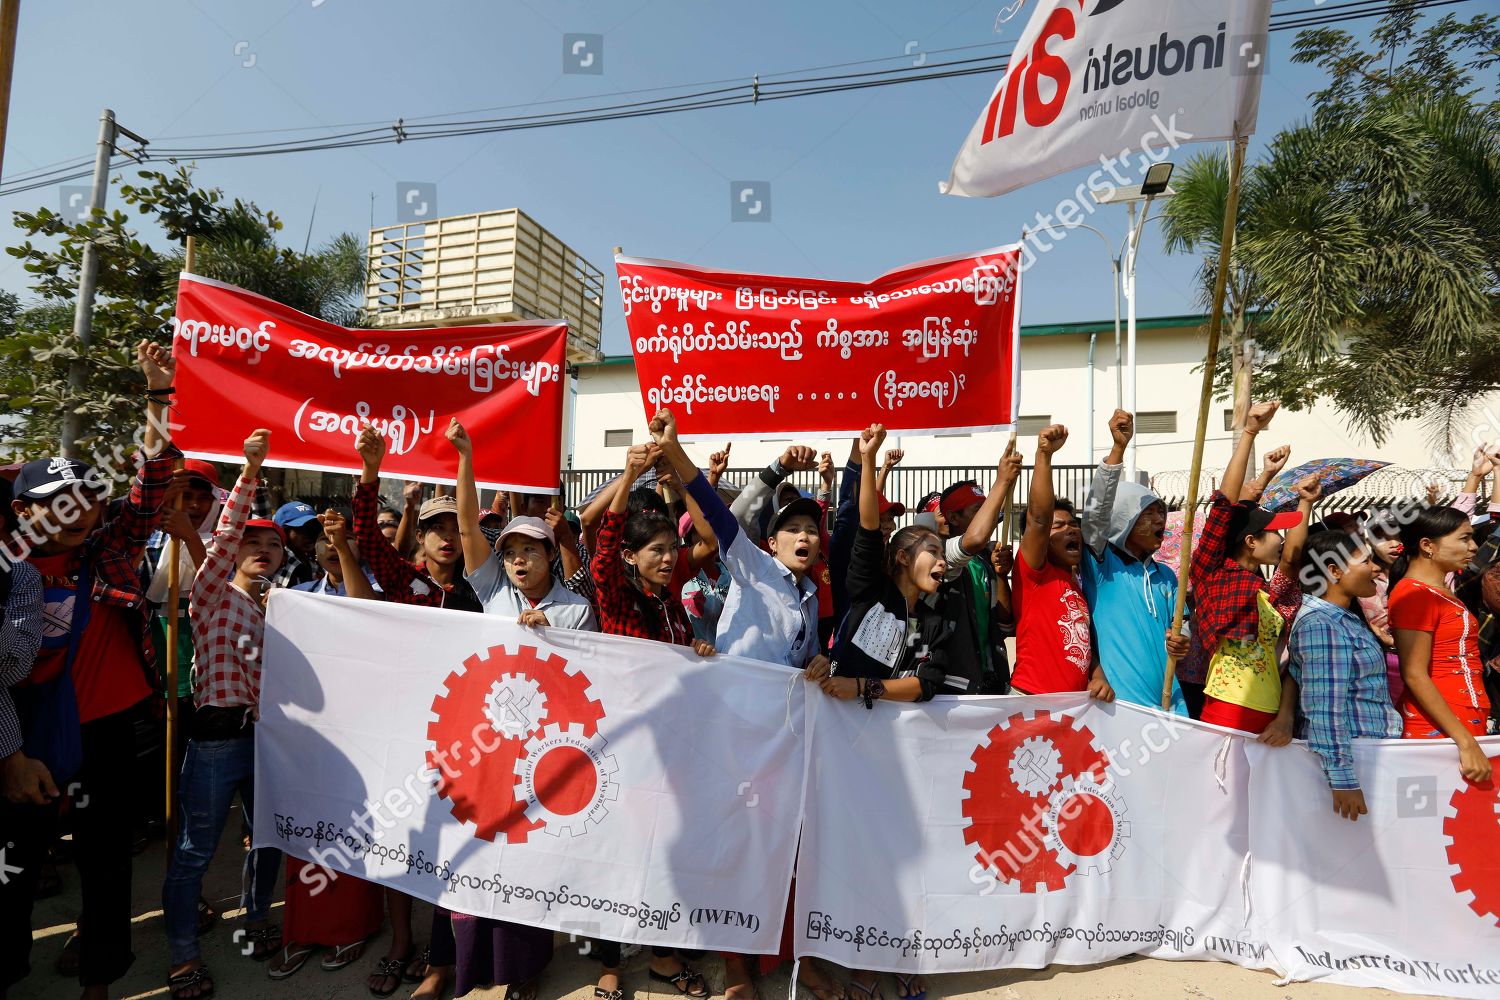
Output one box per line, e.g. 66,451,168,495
963,712,1130,892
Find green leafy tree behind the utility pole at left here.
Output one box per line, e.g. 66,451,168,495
0,168,365,459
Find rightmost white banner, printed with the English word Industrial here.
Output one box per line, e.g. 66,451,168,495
1248,739,1500,997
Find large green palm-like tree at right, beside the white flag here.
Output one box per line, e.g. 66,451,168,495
1167,3,1500,444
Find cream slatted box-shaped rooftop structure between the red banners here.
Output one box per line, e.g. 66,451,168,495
365,208,605,363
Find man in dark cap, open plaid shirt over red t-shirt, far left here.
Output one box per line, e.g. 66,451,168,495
0,340,186,1000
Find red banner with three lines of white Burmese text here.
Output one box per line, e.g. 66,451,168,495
615,246,1020,438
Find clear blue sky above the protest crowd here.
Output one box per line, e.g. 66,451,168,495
0,0,1392,352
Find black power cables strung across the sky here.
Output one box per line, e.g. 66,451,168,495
0,0,1469,196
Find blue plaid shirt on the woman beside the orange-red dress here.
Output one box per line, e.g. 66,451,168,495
1289,594,1401,789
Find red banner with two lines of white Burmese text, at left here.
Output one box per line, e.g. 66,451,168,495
171,273,567,493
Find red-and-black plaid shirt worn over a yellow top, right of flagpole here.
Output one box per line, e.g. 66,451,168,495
1193,490,1302,654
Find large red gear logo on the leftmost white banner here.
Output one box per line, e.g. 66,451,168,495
428,646,615,844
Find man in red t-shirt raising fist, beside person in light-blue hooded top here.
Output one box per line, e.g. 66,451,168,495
1011,424,1115,702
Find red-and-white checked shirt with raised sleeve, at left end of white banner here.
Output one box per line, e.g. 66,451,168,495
188,475,266,708
